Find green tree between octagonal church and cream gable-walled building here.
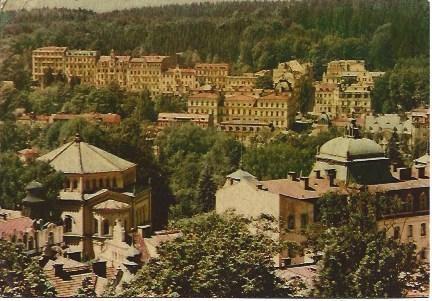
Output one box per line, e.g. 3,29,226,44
156,124,241,218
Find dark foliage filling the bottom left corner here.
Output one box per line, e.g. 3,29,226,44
0,240,56,298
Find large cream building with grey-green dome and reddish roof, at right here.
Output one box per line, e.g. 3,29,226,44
216,119,429,265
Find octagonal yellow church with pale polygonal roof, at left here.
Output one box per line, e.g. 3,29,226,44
38,135,151,258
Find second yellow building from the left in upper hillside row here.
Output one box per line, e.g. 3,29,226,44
65,50,99,85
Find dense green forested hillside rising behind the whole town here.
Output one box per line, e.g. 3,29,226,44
0,0,429,79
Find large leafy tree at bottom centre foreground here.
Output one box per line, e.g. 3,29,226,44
121,213,294,298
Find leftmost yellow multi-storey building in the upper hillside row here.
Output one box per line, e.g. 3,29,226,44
32,46,67,82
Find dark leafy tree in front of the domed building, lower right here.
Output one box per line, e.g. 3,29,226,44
309,192,417,298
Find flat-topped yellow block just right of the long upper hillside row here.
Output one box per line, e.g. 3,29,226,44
195,64,229,89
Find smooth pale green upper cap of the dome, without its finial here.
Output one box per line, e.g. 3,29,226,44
319,137,384,159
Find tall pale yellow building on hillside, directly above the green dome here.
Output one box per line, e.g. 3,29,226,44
313,60,384,119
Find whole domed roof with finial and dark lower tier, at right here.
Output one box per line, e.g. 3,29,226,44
312,120,393,185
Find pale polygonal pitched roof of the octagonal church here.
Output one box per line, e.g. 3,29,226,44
37,137,136,174
